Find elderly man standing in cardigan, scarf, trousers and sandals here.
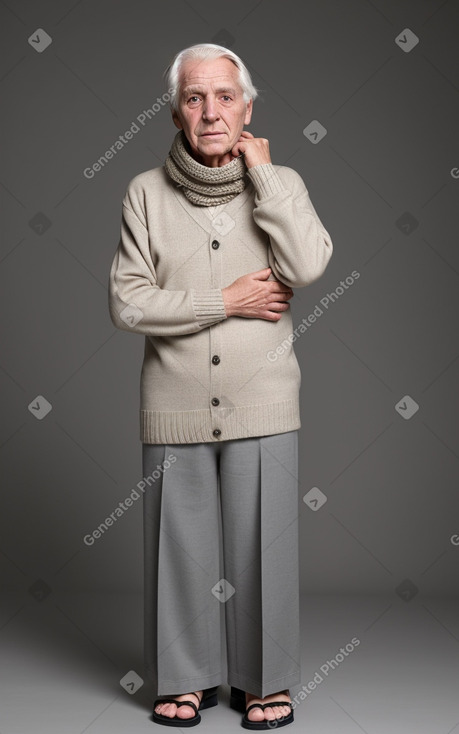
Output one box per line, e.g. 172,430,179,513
109,44,333,729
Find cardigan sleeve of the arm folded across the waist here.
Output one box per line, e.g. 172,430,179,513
108,202,227,336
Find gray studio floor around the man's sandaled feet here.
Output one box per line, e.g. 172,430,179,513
0,589,459,734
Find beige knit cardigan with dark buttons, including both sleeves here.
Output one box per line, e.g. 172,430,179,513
109,163,333,444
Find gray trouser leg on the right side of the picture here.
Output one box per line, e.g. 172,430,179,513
220,431,301,697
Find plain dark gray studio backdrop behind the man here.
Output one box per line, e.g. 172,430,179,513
0,0,459,601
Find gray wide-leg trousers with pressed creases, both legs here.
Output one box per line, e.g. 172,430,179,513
142,431,301,698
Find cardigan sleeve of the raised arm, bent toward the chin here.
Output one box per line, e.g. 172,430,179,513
248,163,333,288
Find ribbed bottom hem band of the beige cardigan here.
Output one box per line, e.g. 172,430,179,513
140,398,301,444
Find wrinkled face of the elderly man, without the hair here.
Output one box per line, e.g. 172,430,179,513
172,58,252,166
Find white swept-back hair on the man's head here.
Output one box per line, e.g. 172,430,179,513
164,43,258,110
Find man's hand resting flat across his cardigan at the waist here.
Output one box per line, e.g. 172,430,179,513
222,268,293,321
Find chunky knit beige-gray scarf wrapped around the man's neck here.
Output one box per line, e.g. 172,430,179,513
164,130,247,206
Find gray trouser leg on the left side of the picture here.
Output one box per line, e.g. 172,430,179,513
142,443,222,695
